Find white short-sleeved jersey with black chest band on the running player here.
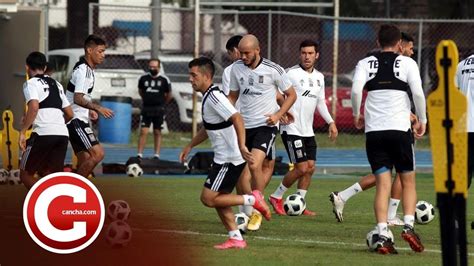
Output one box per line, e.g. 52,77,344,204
202,86,245,165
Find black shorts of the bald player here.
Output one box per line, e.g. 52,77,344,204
245,126,278,156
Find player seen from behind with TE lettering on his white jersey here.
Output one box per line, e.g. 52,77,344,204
351,24,427,254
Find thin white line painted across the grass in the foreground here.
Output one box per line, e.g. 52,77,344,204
132,227,474,257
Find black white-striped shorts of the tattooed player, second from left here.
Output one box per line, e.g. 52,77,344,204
67,118,99,154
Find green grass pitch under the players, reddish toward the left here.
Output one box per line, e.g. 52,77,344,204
0,174,474,266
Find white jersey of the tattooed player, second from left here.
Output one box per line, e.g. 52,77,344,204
66,60,95,123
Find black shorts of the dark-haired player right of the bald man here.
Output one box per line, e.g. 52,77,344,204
281,133,317,163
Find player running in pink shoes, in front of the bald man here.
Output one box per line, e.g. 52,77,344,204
179,57,271,249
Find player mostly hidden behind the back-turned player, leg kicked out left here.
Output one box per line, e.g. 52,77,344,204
329,32,419,226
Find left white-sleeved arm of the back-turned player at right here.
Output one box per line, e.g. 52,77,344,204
351,61,366,129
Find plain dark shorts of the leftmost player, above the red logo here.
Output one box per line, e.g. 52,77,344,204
20,133,68,173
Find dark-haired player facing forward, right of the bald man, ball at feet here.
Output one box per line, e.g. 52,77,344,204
270,40,338,216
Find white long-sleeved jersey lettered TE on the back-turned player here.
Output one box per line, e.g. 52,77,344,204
351,52,427,132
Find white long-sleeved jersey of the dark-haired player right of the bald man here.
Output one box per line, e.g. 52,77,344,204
280,65,334,137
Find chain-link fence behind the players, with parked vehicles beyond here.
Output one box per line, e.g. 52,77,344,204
85,4,474,143
